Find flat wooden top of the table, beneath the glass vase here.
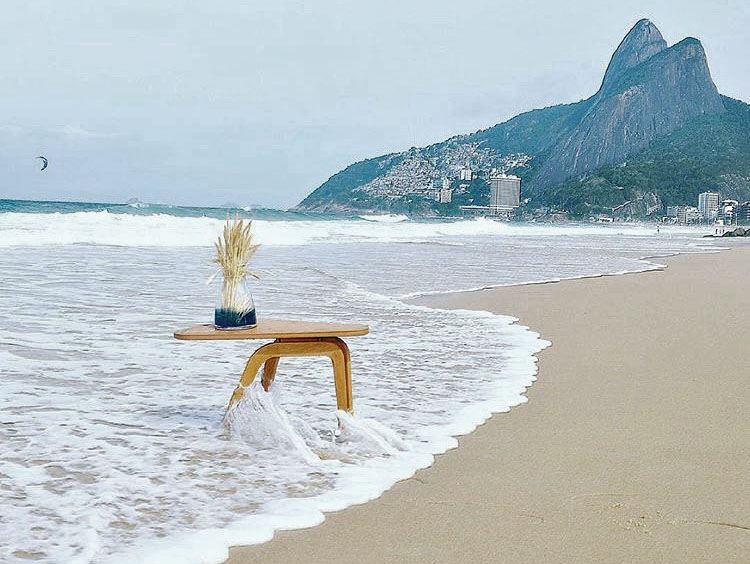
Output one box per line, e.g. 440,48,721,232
174,319,370,341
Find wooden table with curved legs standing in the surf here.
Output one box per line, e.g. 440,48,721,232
174,319,370,412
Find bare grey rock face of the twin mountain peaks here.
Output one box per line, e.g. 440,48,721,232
535,19,725,188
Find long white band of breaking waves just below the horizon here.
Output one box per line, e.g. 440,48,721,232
0,211,708,247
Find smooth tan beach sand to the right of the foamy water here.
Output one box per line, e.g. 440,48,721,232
228,247,750,564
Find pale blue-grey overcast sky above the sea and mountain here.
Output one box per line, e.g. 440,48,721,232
0,0,750,208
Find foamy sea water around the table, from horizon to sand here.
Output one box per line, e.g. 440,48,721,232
0,201,712,564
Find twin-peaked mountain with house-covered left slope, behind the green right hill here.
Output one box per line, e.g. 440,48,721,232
295,19,750,214
